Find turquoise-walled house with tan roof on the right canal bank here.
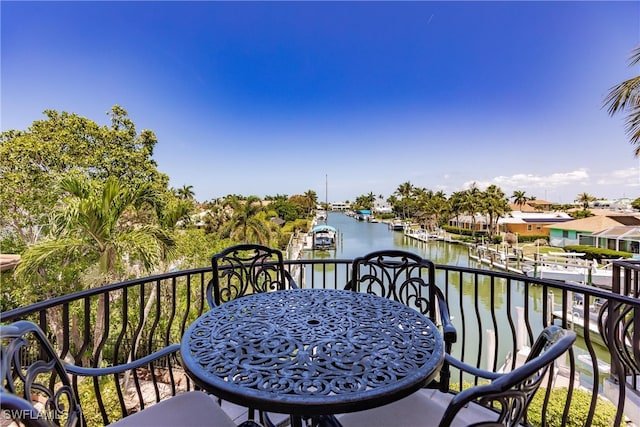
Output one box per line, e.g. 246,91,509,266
545,214,640,248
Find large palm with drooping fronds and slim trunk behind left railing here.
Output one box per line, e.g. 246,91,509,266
16,177,174,363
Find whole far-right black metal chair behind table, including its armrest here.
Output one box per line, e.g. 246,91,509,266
345,250,457,391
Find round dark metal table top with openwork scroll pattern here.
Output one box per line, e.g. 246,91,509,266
181,289,444,415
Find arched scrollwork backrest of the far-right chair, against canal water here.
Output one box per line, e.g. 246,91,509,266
346,249,437,321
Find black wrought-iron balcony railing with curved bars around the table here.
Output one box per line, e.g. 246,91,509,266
0,259,640,426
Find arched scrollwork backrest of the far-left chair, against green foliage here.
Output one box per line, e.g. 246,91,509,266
207,244,289,307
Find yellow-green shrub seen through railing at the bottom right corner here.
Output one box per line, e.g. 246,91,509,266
527,388,616,427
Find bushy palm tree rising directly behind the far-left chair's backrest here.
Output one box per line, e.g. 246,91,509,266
220,196,272,245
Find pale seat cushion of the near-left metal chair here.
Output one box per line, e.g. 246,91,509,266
109,391,236,427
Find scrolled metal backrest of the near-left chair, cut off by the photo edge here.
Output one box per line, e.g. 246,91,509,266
0,321,82,426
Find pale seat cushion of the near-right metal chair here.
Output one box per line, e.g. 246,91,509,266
336,389,498,427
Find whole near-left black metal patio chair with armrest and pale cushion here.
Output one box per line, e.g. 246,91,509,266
0,321,259,427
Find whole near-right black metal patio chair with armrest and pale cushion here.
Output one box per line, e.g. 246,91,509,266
336,326,576,427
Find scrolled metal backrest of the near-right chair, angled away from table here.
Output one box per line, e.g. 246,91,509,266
440,326,576,427
